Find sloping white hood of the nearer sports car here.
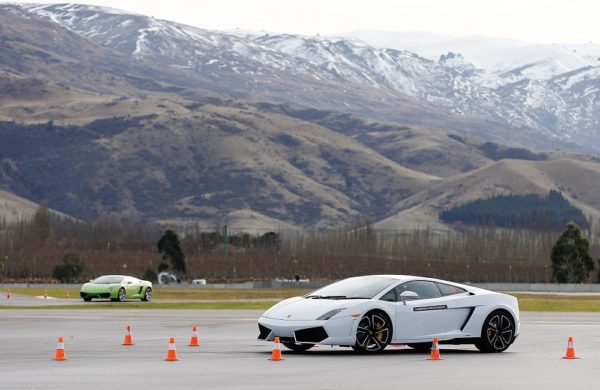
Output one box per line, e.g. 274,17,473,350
263,298,365,321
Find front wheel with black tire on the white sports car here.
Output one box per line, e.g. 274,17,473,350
352,310,393,353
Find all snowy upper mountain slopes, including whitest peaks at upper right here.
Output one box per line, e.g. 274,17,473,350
5,4,600,149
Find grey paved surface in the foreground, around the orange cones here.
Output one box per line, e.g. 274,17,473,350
0,309,600,390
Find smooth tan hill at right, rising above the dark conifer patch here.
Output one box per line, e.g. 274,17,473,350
376,158,600,229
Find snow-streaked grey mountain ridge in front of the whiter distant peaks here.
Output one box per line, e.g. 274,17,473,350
7,4,600,150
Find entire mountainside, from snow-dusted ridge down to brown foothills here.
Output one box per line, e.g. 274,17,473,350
0,5,600,229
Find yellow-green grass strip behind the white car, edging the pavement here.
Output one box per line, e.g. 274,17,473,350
0,287,600,312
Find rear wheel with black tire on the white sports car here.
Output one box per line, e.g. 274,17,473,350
475,310,515,353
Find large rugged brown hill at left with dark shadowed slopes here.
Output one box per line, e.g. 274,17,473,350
0,96,439,226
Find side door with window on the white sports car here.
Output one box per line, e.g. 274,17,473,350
394,280,468,341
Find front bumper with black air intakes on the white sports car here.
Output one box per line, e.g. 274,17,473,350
258,316,358,346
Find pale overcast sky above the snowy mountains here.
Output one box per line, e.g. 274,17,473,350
5,0,600,43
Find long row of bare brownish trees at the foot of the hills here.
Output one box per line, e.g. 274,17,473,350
0,205,600,282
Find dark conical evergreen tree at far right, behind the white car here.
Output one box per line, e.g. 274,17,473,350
551,222,594,283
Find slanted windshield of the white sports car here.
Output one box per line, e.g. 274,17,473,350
305,276,398,299
